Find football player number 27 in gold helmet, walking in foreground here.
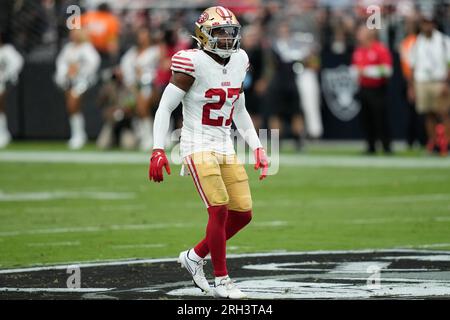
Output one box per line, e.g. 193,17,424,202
149,6,268,299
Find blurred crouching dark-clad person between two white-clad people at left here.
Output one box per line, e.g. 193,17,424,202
97,68,137,150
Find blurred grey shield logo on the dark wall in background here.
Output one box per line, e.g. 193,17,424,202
322,65,360,121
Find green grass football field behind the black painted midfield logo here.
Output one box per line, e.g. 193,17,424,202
0,143,450,269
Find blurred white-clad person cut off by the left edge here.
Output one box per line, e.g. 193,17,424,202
0,32,23,149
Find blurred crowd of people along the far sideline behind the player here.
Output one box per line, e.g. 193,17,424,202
0,0,450,154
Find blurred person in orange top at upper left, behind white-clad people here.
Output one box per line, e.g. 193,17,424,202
81,3,120,67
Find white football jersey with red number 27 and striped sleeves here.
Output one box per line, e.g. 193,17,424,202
171,49,249,157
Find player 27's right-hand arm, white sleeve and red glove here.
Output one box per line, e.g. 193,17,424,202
233,86,269,180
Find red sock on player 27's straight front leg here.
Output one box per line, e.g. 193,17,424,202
206,205,228,277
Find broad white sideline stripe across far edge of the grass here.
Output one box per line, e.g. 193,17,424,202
0,151,450,169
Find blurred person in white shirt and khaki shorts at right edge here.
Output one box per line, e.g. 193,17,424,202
409,15,450,152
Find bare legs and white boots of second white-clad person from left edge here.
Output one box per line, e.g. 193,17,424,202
66,89,87,149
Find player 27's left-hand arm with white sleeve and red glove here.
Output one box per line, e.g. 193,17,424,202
148,72,195,182
